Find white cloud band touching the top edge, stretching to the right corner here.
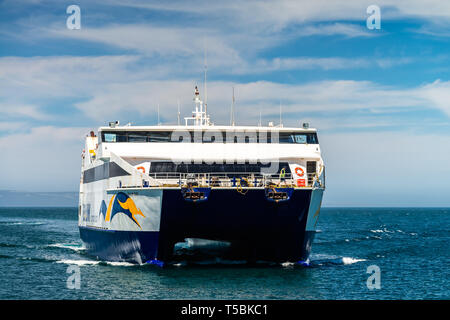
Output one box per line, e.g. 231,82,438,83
109,0,450,31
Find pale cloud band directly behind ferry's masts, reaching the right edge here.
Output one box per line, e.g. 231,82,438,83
69,80,449,129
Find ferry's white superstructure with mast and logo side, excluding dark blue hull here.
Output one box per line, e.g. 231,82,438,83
79,87,325,260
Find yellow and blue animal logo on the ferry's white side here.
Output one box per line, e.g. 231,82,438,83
100,192,145,229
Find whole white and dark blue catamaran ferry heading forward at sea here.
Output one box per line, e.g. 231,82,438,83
78,87,325,266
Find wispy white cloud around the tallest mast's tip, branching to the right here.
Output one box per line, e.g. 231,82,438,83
31,24,412,75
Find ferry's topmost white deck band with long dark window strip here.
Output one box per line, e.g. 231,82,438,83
93,126,321,162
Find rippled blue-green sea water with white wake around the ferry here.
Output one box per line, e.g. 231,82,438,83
0,208,450,300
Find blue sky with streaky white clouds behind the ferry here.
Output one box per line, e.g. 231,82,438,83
0,0,450,207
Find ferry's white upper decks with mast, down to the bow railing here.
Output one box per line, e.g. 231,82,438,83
83,89,324,187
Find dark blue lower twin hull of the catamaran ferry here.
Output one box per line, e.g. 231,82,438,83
80,189,315,263
